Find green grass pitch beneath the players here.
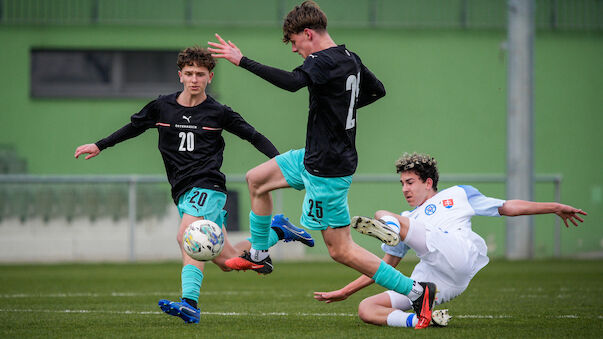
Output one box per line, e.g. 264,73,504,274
0,260,603,338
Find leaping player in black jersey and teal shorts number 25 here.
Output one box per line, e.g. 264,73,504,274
209,1,436,328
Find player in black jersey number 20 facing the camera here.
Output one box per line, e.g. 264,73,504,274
75,47,314,323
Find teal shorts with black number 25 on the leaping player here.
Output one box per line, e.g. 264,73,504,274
275,148,352,230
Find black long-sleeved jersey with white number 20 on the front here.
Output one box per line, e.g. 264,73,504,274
96,92,278,203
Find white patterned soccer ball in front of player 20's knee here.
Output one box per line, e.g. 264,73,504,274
182,219,224,261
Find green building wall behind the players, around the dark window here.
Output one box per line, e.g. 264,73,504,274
0,20,603,257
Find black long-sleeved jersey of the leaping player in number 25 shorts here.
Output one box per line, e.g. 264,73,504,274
240,45,385,177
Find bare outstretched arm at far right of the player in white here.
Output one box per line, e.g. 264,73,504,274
498,200,588,227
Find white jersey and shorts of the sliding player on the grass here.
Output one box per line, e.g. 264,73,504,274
381,186,505,304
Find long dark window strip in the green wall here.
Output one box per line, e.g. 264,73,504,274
31,49,196,98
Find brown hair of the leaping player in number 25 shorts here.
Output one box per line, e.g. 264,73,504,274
283,0,327,43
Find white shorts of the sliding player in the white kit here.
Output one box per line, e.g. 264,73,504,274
388,219,489,310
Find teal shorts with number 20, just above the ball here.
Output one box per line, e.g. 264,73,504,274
178,187,226,227
